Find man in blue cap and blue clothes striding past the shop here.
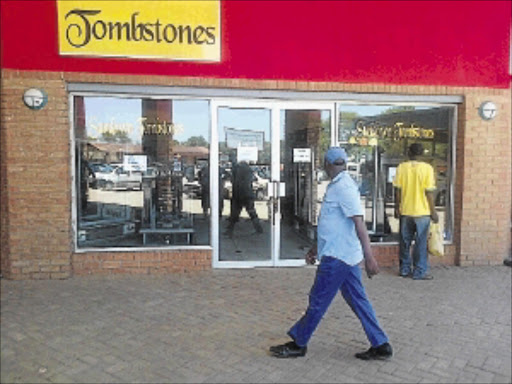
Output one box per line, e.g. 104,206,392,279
270,147,393,360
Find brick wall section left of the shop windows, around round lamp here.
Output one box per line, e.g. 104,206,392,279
1,69,72,279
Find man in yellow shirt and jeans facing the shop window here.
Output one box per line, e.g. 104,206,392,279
393,143,439,280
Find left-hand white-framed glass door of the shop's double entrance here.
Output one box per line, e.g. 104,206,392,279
215,101,274,267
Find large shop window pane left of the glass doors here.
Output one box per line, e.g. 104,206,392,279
74,96,210,248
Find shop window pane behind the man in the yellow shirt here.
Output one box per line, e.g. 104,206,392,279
337,104,455,242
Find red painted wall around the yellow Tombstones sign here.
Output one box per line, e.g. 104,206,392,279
0,0,512,88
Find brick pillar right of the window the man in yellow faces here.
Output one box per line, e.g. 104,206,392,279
460,89,512,266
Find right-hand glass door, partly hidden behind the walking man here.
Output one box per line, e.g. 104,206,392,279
277,103,334,266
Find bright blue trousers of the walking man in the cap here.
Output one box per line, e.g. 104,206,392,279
288,256,388,347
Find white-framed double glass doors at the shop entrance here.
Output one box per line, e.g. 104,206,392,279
214,102,333,267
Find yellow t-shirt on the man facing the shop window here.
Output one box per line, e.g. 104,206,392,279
393,161,436,216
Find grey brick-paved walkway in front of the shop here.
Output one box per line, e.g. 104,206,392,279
0,266,512,383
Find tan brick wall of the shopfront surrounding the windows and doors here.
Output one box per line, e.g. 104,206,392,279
0,70,512,279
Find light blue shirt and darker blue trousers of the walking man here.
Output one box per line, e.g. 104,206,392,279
288,172,389,347
